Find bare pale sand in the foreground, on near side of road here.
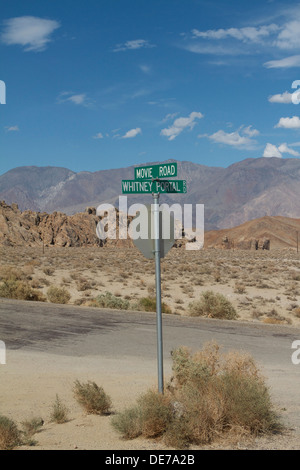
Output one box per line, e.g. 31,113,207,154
0,350,300,451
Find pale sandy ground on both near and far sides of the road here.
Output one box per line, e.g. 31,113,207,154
0,248,300,450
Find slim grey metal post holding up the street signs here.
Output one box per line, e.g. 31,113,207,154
153,193,164,393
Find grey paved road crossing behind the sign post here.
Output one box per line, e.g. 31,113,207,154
0,299,300,429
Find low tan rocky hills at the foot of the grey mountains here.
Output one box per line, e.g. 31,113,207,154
0,201,300,250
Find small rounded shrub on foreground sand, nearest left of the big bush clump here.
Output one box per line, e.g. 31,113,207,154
73,380,112,415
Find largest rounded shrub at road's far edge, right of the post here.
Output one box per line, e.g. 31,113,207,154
188,291,238,320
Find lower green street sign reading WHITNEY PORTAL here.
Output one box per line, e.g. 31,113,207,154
122,180,187,194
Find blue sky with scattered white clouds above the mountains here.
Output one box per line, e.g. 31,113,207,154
0,0,300,174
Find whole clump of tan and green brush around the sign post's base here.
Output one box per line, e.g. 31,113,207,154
112,343,281,448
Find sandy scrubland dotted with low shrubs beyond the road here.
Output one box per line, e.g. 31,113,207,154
0,247,300,326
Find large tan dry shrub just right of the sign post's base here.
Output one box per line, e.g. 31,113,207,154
166,343,280,444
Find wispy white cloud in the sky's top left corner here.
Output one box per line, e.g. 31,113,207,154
1,16,60,51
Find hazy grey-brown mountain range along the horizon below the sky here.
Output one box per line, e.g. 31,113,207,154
0,157,300,230
